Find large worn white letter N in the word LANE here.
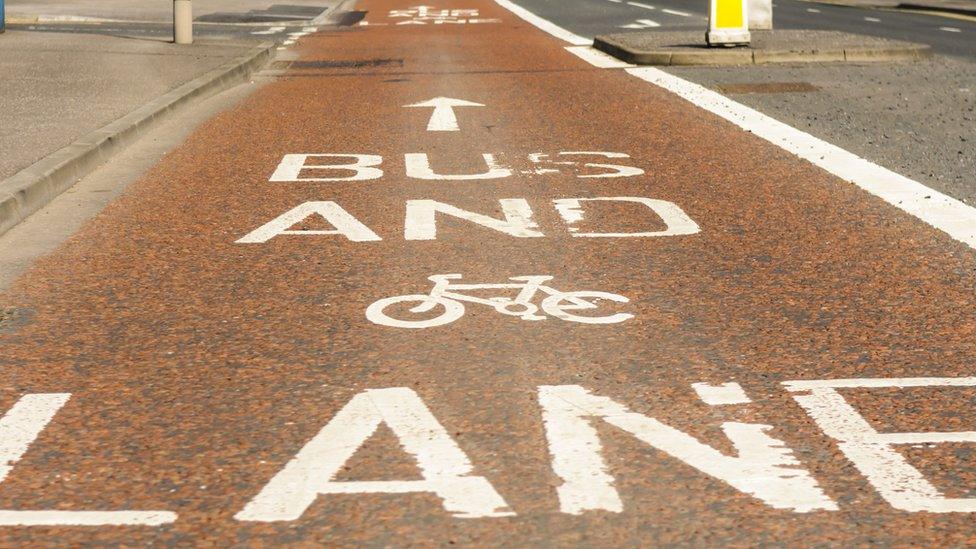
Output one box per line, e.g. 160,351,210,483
539,385,837,515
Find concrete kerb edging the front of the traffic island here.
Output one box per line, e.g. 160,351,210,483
593,36,932,66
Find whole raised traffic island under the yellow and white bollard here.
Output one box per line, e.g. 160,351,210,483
593,30,932,65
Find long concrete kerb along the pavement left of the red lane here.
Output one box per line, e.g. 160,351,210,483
0,43,275,238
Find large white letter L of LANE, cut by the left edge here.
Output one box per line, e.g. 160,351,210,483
0,393,177,526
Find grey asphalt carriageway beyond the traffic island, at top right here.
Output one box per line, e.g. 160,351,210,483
517,0,976,58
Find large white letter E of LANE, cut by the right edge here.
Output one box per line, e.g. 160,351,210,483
783,377,976,513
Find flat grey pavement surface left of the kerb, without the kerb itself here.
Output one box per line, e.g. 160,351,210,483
0,28,255,180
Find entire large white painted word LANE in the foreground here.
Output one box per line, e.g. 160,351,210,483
0,377,976,527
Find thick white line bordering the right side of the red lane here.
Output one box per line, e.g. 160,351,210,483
495,0,976,249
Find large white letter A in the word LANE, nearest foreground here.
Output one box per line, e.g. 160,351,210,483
234,387,515,522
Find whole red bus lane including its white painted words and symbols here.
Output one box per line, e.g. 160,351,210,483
0,0,976,547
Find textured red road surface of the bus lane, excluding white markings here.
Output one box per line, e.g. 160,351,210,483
0,0,976,546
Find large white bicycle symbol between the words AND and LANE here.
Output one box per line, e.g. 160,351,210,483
366,274,634,328
